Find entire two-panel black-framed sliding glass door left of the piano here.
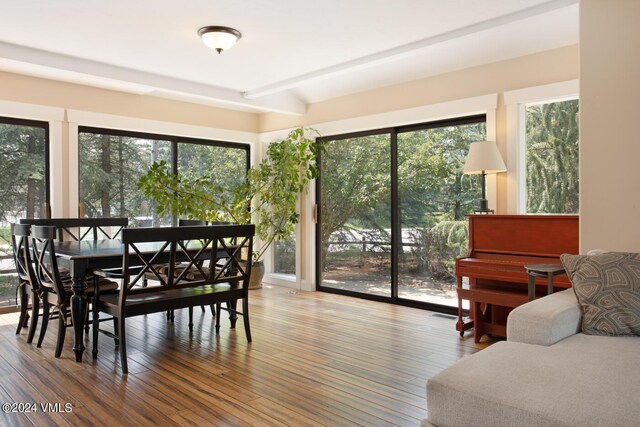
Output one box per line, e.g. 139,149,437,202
316,116,486,307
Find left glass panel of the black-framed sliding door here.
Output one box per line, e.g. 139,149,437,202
319,133,391,297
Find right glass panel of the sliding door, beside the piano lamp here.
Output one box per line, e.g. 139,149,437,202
398,122,486,306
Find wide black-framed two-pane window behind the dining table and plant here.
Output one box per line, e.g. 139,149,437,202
79,127,249,226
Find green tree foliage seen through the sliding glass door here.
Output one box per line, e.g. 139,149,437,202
320,123,486,280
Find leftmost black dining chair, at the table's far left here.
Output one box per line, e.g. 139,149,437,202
11,224,40,343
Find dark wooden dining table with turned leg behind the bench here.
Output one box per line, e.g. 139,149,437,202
55,240,227,362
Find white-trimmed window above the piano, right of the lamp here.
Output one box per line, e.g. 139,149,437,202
524,99,579,214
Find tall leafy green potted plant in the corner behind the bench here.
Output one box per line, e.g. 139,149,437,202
138,128,319,288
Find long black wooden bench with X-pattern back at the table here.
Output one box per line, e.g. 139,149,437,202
92,225,255,374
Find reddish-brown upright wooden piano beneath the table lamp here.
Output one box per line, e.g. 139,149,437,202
456,215,579,342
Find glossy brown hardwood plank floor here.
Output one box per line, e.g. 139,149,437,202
0,287,487,426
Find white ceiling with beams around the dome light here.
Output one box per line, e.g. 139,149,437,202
0,0,578,114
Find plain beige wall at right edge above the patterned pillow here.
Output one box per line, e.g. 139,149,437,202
580,0,640,253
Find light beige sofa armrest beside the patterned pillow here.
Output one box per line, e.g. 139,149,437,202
507,289,582,346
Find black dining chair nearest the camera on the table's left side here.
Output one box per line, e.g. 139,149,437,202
31,225,118,357
